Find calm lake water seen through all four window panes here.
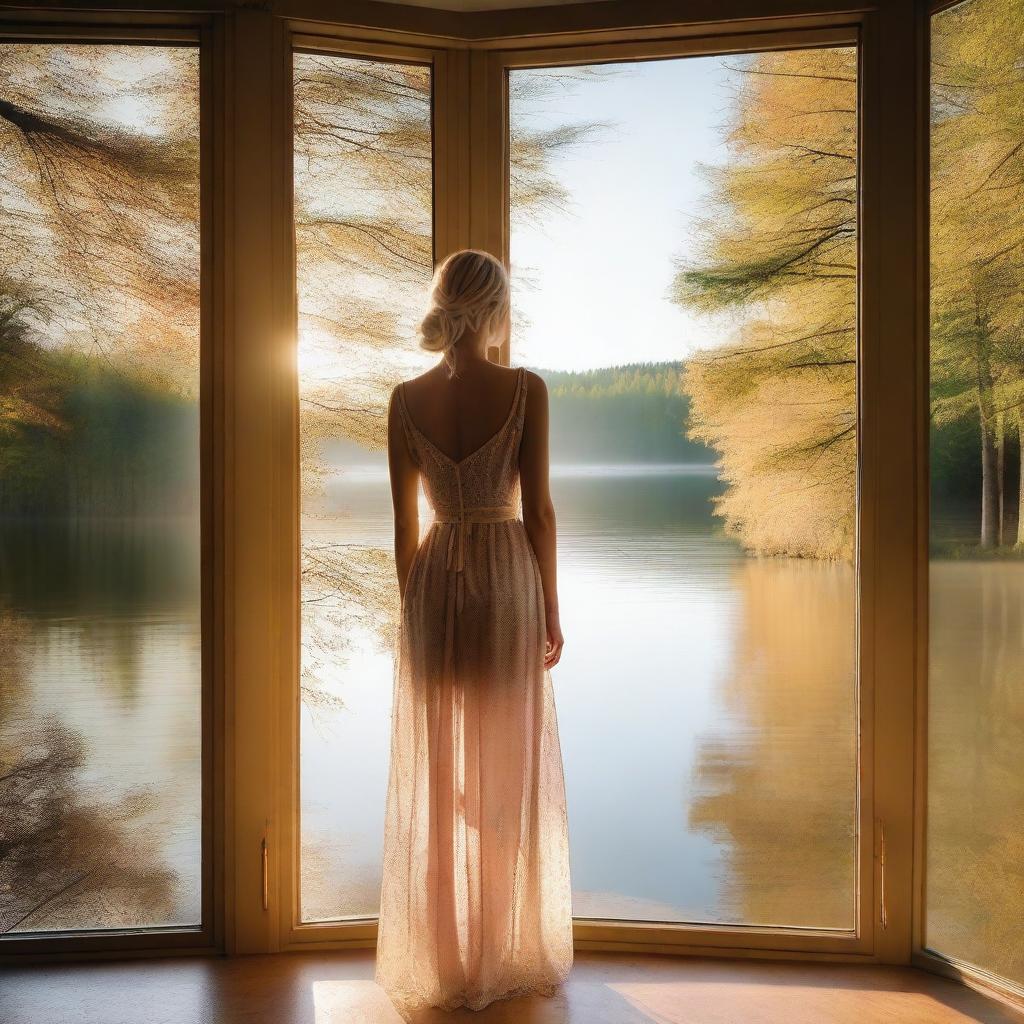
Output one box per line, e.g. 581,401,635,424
0,467,1024,962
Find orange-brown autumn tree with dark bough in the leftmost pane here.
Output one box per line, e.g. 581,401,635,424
0,43,199,394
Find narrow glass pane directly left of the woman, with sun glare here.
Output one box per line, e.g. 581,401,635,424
295,53,433,921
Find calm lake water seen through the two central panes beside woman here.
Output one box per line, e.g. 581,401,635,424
302,466,856,928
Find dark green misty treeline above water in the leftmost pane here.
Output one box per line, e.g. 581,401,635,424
0,339,199,518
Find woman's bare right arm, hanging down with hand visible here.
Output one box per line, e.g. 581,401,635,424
519,373,565,669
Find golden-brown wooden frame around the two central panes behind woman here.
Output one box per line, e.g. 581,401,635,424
268,4,918,962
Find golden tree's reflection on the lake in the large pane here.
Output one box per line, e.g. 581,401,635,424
689,558,857,928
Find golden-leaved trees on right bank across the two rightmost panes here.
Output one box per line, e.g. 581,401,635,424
675,0,1024,558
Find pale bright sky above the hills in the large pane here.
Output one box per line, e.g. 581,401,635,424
510,56,736,370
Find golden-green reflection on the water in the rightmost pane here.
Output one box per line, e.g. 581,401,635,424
926,559,1024,983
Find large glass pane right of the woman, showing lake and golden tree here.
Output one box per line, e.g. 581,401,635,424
510,48,858,929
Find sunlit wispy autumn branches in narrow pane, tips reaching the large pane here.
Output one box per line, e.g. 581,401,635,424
294,54,598,460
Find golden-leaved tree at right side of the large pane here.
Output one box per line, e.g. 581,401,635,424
675,48,857,558
